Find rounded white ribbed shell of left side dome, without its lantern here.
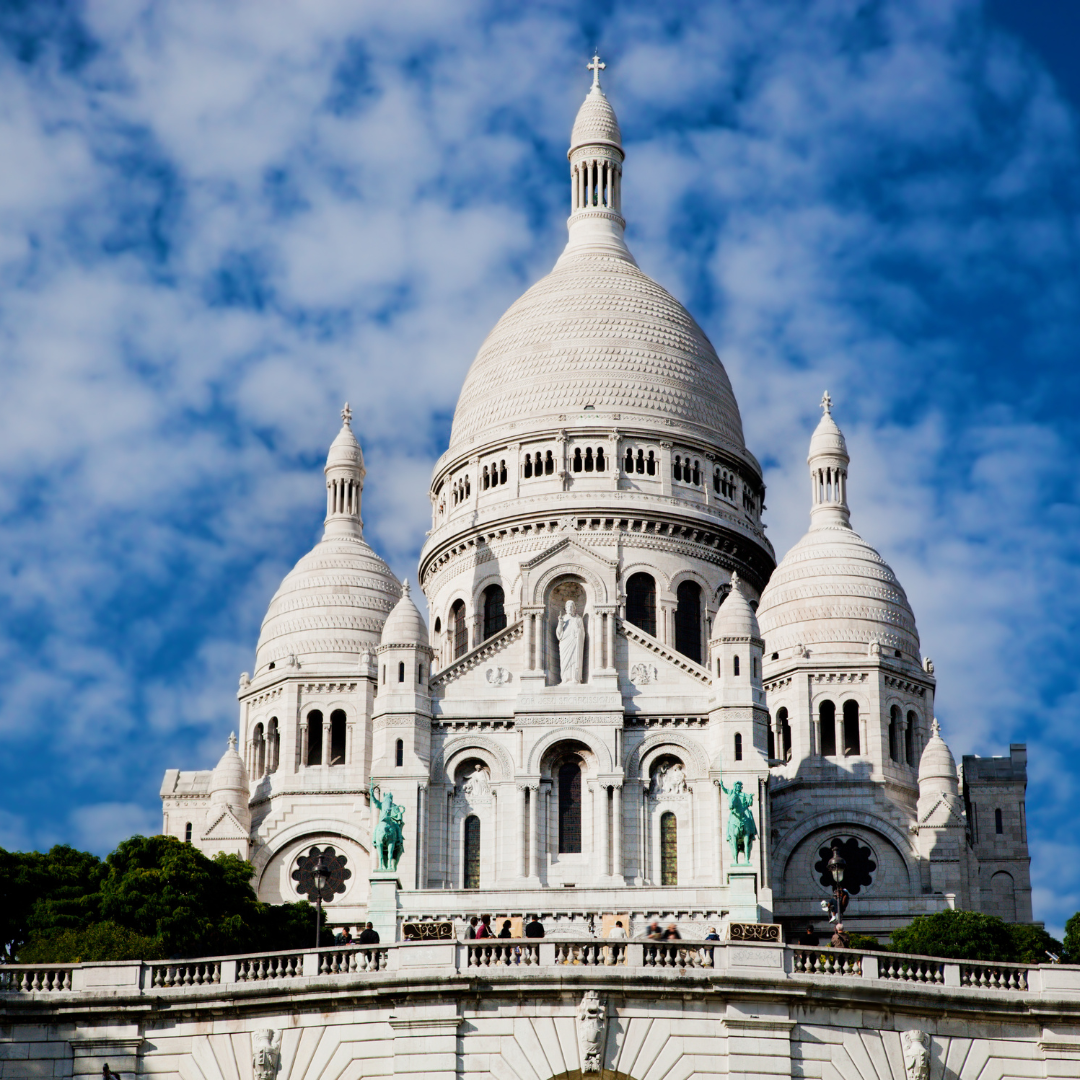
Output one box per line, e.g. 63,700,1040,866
255,536,401,674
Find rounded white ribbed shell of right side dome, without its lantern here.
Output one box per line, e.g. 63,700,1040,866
757,525,919,663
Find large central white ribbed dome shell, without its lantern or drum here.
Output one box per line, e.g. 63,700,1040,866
450,251,744,454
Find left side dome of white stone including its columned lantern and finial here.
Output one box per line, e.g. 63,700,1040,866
255,405,402,677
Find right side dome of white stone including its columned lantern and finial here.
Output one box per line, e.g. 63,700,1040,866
757,394,919,666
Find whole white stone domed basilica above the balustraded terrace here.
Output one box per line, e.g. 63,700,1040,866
161,60,1031,941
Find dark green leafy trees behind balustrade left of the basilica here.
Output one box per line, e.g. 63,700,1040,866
6,836,333,963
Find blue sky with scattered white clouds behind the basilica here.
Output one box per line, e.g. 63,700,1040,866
0,0,1080,928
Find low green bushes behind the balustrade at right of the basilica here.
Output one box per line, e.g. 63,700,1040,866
890,910,1058,963
